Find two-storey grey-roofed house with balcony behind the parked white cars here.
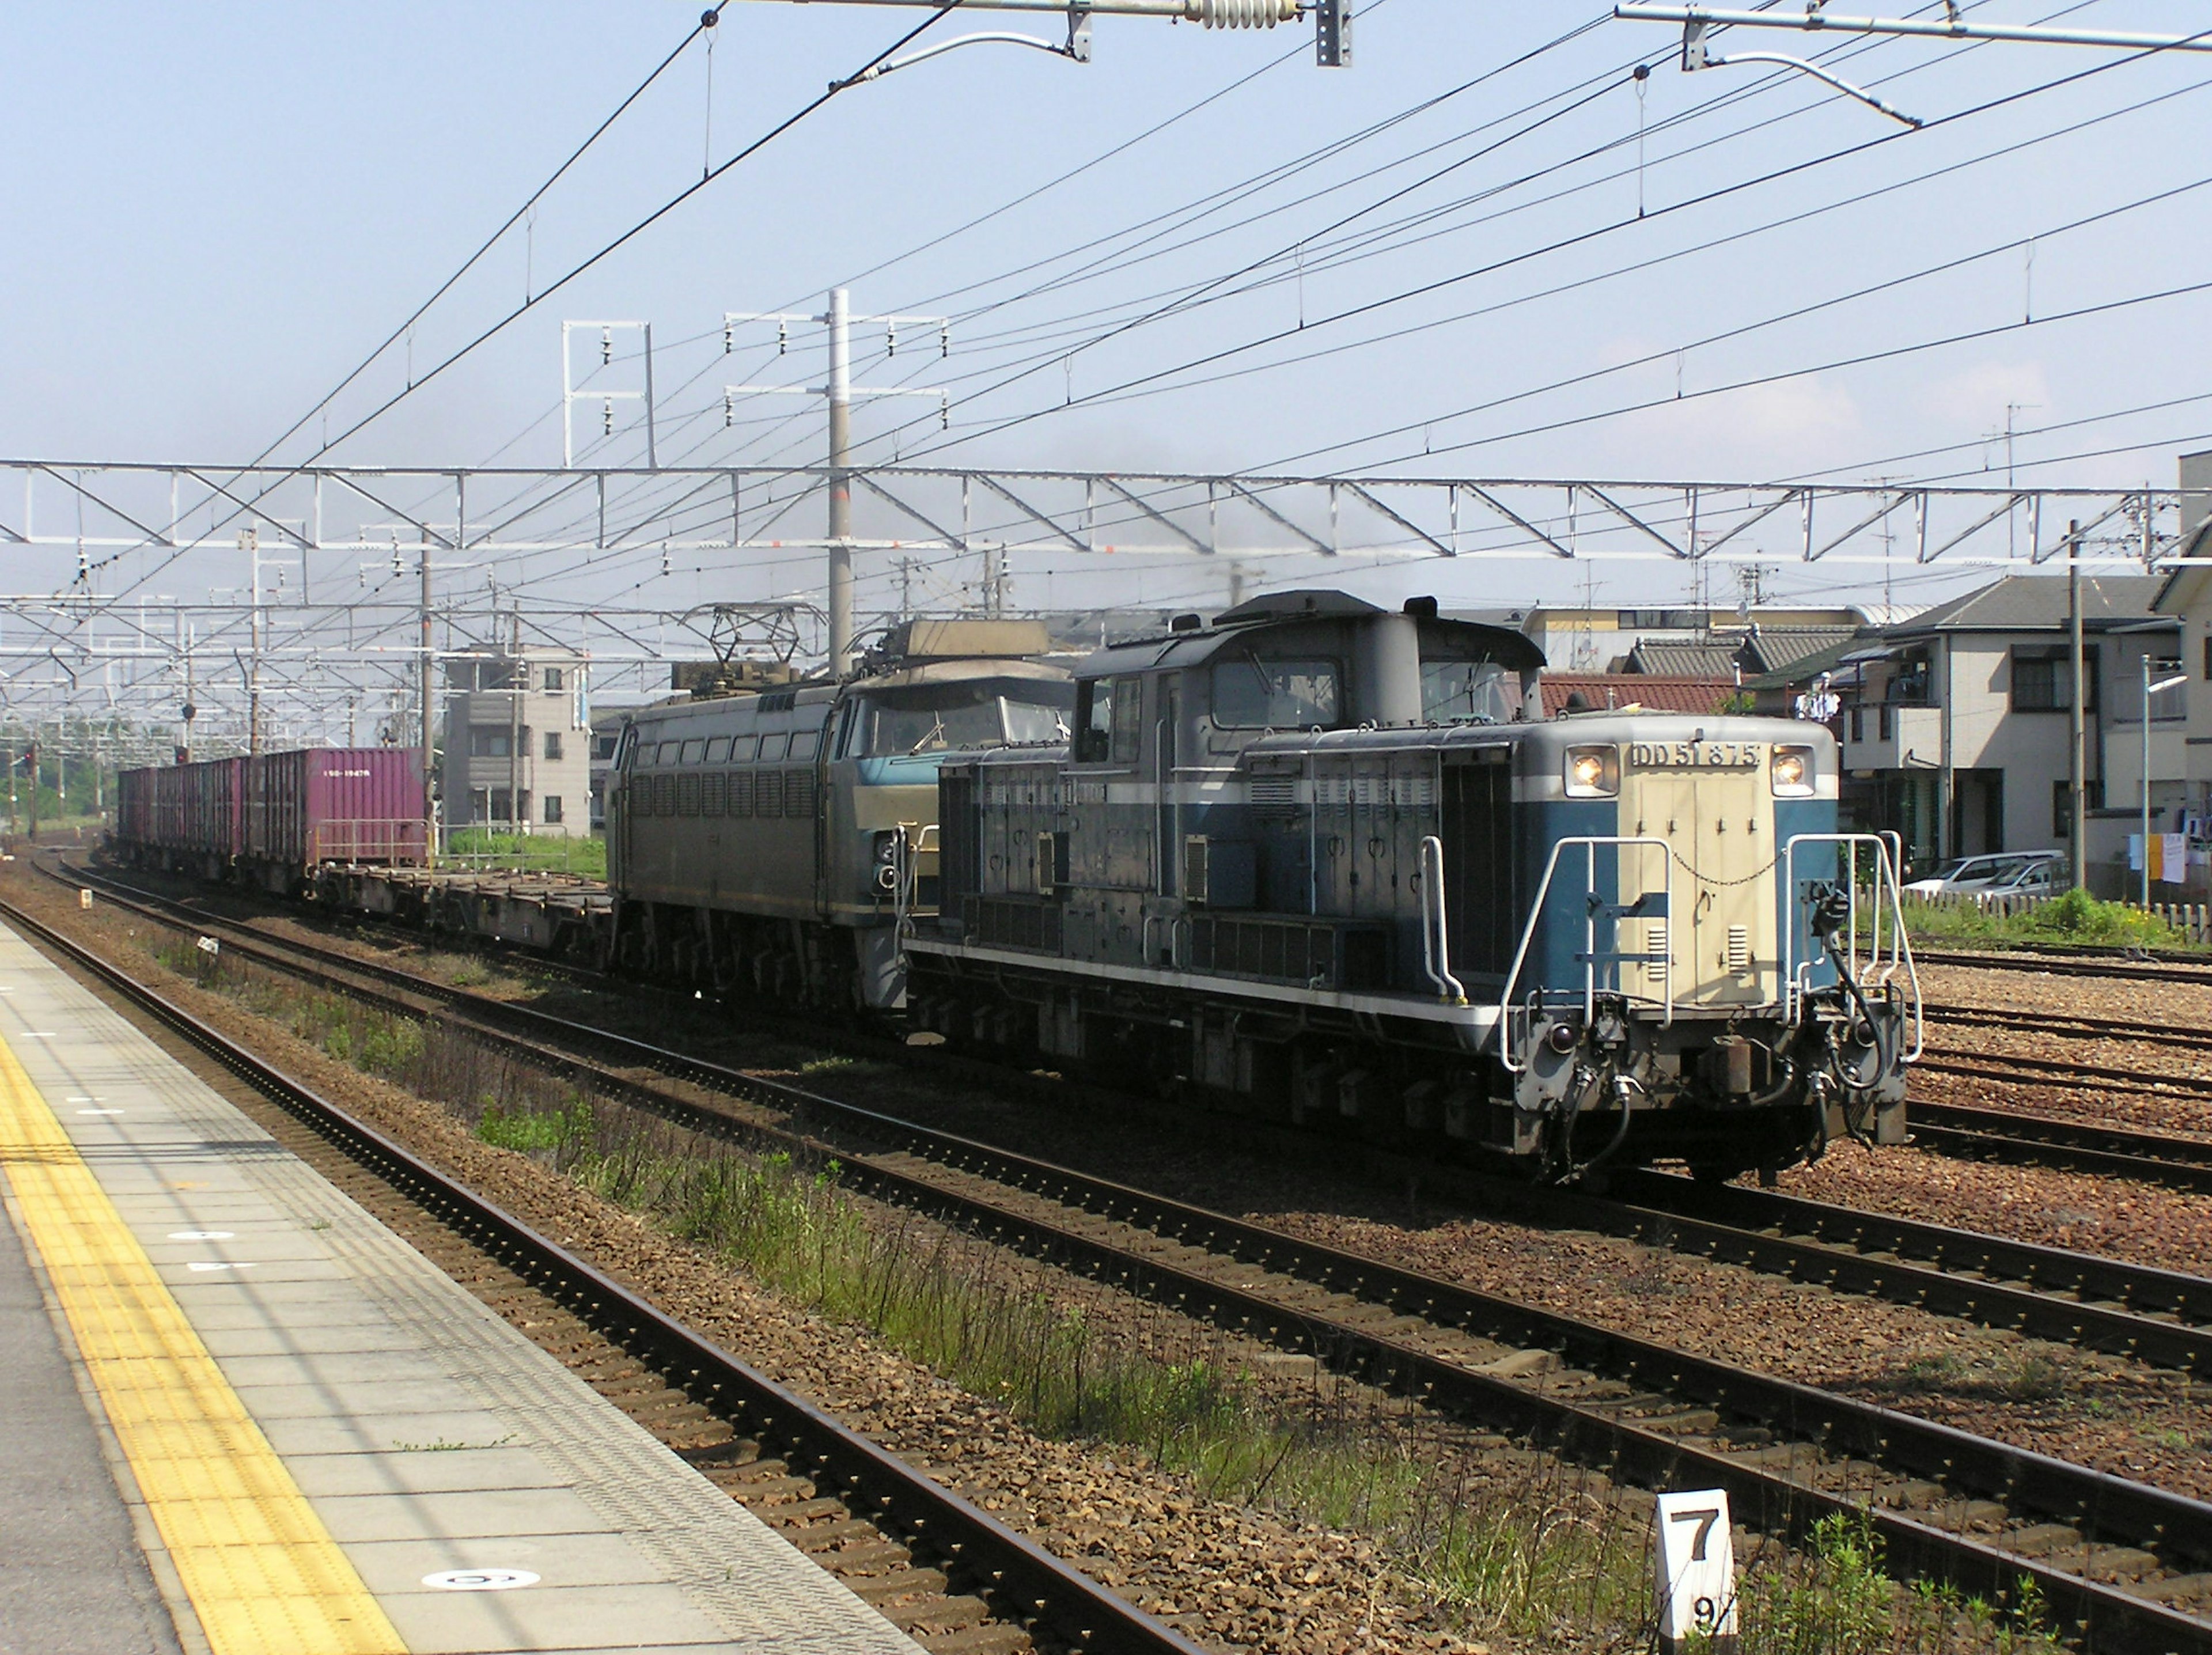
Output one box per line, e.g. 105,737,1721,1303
1830,575,2183,896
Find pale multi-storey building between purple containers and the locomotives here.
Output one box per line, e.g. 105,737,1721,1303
438,650,590,836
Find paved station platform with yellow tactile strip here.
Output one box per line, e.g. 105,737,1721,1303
0,929,918,1655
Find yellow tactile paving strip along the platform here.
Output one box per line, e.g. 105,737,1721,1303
0,1040,407,1655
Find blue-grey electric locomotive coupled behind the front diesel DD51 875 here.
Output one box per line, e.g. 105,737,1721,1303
606,622,1075,1011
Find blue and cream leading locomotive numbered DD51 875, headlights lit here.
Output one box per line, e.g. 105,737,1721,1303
903,593,1918,1179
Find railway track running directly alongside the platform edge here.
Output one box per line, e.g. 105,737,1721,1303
0,903,1199,1655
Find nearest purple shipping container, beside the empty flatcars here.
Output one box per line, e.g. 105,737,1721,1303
241,748,425,869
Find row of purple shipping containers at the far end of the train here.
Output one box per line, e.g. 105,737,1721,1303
115,748,429,894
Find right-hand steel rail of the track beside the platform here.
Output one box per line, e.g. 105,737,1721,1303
0,900,1199,1655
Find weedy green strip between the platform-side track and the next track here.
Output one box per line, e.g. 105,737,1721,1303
155,929,2057,1655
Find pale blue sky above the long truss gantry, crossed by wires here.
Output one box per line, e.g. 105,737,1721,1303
0,0,2212,633
